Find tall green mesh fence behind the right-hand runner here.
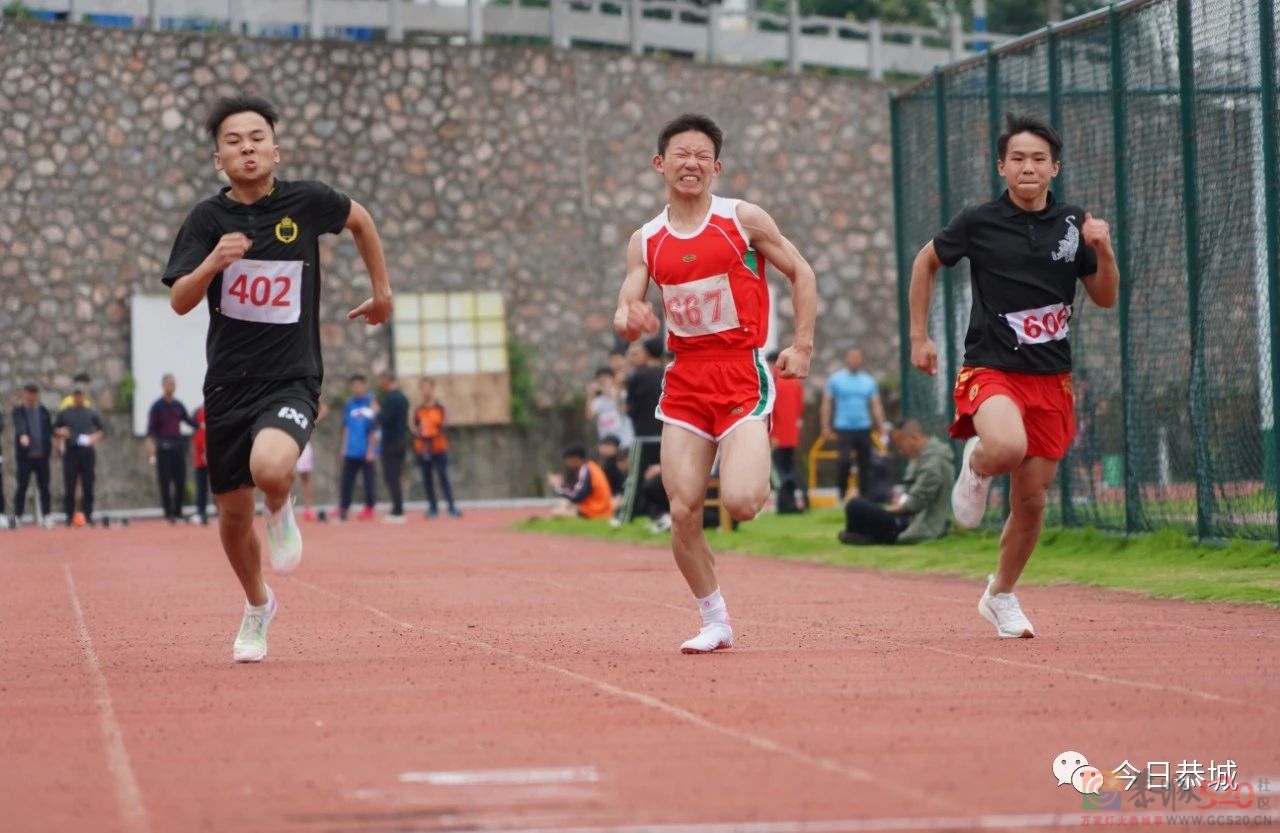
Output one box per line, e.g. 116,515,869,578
892,0,1280,543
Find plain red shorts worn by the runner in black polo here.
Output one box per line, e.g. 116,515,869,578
950,367,1075,459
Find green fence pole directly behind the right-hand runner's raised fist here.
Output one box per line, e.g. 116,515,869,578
1107,6,1142,532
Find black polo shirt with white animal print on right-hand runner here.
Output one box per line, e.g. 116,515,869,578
933,191,1098,375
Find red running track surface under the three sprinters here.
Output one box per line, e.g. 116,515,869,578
0,512,1280,833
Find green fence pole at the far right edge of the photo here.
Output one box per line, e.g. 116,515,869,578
1258,0,1280,545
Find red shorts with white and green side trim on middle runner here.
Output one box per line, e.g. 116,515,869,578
657,351,777,443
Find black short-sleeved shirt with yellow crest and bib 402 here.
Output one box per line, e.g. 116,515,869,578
164,179,351,388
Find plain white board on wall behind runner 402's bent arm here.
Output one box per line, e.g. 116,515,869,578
129,294,209,436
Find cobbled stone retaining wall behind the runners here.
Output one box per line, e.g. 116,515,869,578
0,20,897,496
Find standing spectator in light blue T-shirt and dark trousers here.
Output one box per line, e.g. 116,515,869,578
822,347,884,498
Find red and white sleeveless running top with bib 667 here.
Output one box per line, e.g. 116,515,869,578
641,196,769,356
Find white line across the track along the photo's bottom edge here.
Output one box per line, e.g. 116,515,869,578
460,814,1084,833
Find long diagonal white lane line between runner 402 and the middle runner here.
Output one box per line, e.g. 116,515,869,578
294,580,938,804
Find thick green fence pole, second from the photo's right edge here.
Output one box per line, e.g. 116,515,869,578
1178,0,1213,540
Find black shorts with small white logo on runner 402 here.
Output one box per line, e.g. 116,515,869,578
205,377,320,495
